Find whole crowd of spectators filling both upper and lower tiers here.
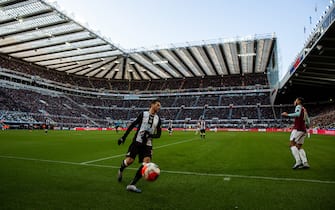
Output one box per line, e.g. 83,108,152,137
0,56,335,128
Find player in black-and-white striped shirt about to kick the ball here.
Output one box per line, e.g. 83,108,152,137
118,100,162,193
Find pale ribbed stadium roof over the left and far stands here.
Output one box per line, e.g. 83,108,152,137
0,0,276,80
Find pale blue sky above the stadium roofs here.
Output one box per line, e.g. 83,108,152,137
49,0,330,77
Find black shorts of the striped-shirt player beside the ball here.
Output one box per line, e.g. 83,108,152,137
126,141,152,163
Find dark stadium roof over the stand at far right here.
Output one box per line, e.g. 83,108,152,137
277,5,335,103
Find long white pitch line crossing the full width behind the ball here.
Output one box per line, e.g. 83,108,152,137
0,155,335,184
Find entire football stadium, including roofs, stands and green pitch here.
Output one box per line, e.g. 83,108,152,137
0,0,335,210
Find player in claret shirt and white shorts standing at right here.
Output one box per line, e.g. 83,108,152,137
281,97,310,169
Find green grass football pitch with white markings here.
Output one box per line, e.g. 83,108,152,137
0,130,335,210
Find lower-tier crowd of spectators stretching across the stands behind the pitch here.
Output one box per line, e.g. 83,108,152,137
0,83,335,128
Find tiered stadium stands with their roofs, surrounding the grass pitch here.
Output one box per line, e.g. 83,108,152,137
0,0,335,128
